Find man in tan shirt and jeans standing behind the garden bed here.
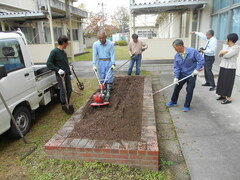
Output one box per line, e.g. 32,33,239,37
128,34,148,76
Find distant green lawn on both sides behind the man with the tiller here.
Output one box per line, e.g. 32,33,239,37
75,46,130,61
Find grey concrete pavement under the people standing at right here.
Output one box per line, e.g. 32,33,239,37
159,66,240,180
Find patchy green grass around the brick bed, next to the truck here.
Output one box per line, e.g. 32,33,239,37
0,78,172,180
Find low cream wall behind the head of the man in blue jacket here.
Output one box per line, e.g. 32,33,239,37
141,38,189,60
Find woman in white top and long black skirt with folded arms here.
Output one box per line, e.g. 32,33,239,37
216,33,240,104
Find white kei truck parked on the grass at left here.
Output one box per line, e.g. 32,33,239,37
0,30,58,138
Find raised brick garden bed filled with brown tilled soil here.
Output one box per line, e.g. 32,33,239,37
45,76,158,170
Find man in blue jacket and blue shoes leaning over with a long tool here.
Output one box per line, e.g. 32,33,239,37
166,39,205,112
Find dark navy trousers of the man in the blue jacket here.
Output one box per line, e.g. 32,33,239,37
171,76,196,107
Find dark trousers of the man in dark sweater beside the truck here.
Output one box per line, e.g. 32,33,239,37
56,75,72,104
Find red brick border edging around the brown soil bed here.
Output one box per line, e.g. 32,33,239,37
44,77,159,170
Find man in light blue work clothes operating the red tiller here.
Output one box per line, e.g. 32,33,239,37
93,31,116,89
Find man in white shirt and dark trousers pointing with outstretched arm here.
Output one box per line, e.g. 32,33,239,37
191,30,217,91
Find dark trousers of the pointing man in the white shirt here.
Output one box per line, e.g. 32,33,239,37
204,55,216,87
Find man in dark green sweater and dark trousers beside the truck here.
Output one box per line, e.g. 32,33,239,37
47,35,73,111
